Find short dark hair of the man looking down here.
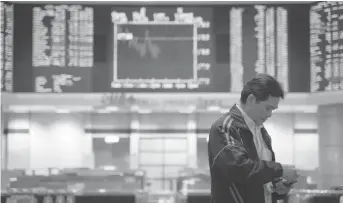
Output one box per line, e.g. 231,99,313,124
241,74,284,104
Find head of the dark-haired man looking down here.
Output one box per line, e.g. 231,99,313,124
241,74,284,125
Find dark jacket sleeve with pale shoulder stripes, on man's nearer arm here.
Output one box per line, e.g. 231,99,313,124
208,125,283,184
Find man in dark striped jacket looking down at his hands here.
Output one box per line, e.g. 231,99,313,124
208,74,298,203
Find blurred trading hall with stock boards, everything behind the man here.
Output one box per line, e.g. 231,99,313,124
1,1,343,203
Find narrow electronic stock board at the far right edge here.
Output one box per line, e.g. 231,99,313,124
310,1,343,92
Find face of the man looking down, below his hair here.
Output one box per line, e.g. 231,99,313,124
247,95,280,125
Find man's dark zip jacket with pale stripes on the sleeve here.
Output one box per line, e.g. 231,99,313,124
208,105,283,203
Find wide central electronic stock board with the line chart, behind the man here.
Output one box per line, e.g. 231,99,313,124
2,3,310,93
